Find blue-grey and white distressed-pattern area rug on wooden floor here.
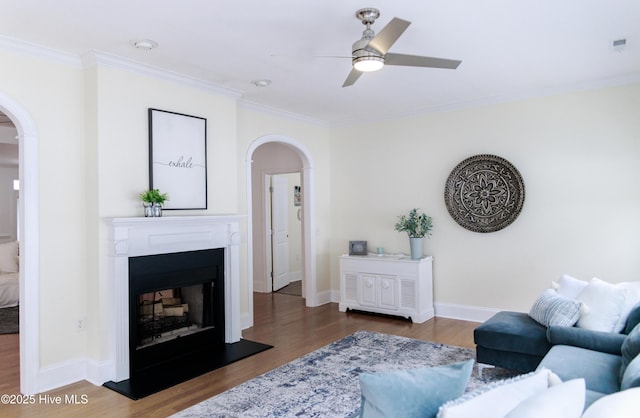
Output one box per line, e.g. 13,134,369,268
172,331,517,418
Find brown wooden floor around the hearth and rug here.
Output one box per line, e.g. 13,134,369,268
0,293,478,418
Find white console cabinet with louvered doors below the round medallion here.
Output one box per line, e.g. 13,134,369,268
339,254,434,323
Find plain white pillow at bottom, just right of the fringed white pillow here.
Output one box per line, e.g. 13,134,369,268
505,379,586,418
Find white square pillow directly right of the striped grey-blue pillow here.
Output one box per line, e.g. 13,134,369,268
577,277,627,332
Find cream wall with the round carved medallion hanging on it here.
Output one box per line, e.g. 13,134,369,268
331,85,640,311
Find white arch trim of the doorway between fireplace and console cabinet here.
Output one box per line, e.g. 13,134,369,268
246,135,318,323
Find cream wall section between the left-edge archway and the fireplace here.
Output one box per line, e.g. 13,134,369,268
0,50,87,367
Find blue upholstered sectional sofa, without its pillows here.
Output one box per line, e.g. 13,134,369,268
474,305,640,408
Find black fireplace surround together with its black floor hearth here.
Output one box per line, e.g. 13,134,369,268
105,248,271,399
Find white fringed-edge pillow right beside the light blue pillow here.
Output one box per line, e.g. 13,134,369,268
437,369,557,418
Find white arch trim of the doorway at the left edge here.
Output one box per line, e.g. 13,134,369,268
0,92,40,395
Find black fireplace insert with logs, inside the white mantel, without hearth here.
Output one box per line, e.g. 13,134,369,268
129,248,225,379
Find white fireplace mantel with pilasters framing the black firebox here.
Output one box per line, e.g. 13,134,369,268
106,215,244,382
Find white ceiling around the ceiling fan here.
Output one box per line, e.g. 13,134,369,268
0,0,640,124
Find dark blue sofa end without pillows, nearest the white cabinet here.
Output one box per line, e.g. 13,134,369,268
473,311,551,357
